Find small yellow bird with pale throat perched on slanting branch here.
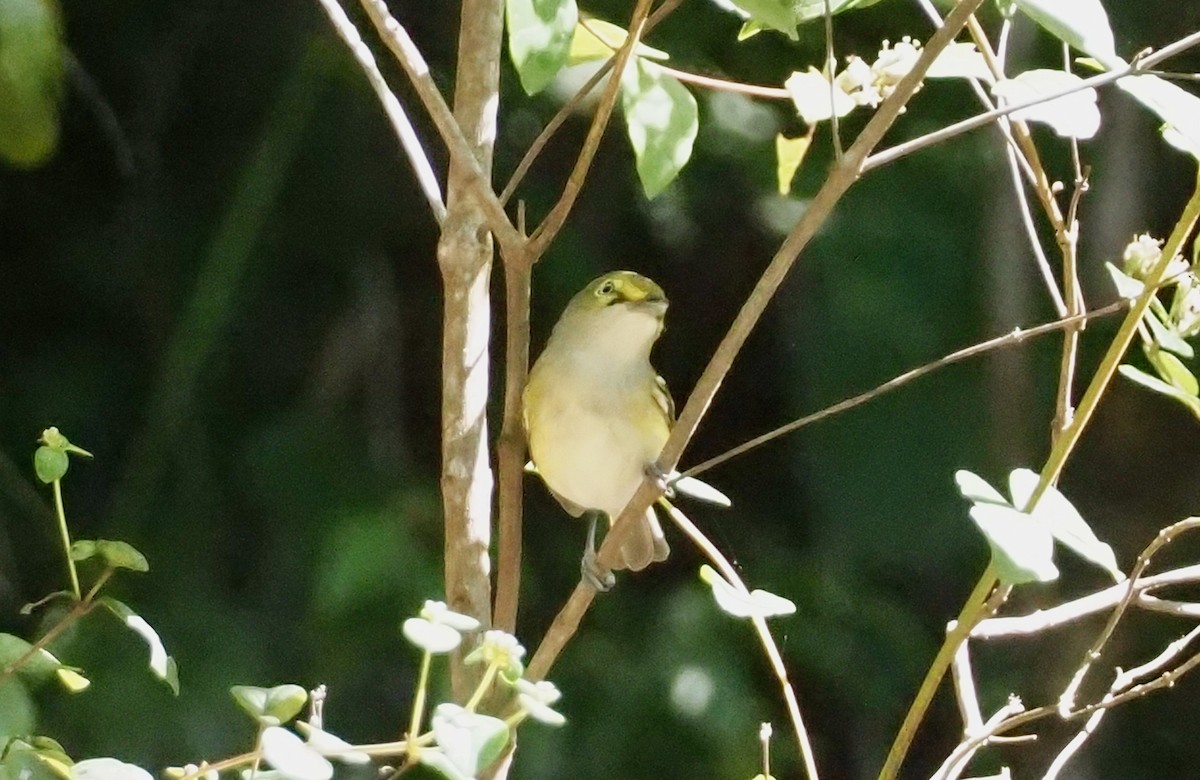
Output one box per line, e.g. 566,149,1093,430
524,271,674,580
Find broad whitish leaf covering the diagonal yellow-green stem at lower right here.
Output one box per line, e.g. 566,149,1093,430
971,504,1058,584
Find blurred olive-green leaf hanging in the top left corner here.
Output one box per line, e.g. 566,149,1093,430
0,0,64,168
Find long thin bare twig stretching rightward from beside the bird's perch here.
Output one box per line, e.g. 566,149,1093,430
684,299,1130,476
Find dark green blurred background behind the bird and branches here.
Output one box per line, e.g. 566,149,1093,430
0,0,1200,778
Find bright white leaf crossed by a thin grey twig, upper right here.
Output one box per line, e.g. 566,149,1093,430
991,70,1100,138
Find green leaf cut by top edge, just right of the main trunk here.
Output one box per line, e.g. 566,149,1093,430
505,0,580,95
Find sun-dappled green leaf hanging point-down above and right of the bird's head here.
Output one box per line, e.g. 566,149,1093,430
620,59,700,198
